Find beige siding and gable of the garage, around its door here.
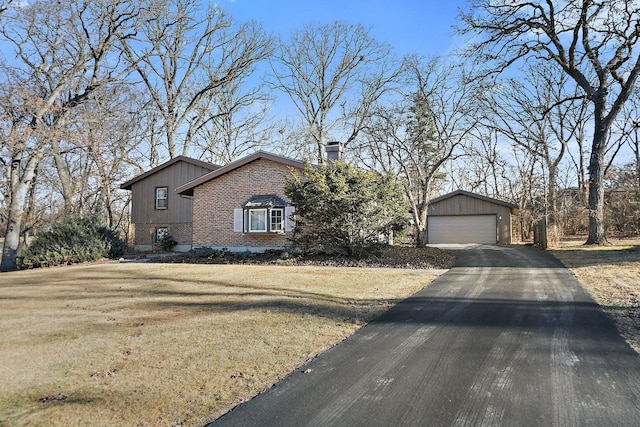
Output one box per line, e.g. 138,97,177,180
427,194,511,244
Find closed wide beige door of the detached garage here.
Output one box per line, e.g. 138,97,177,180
427,215,497,243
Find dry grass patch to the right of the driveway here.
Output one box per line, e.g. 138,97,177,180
552,239,640,352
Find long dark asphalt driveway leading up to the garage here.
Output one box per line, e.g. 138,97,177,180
211,246,640,426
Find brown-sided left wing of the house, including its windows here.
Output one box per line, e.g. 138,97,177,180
120,156,220,251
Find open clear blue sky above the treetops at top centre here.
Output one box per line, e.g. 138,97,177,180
218,0,465,56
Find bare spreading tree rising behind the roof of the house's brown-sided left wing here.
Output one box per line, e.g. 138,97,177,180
122,0,272,158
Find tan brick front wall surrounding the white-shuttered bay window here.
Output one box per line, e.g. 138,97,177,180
193,159,300,249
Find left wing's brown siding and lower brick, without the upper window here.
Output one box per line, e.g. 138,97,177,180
131,161,210,249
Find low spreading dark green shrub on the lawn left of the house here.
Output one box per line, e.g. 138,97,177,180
18,216,126,269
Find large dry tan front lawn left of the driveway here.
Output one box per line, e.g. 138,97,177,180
0,263,437,426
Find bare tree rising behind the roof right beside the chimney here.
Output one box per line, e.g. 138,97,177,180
270,22,396,163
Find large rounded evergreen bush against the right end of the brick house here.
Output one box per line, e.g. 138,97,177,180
285,162,408,257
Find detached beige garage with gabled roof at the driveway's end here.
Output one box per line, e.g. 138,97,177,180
427,190,518,245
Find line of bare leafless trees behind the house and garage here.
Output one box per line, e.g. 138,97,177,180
0,0,640,270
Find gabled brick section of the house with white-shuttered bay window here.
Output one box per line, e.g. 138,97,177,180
176,151,304,252
